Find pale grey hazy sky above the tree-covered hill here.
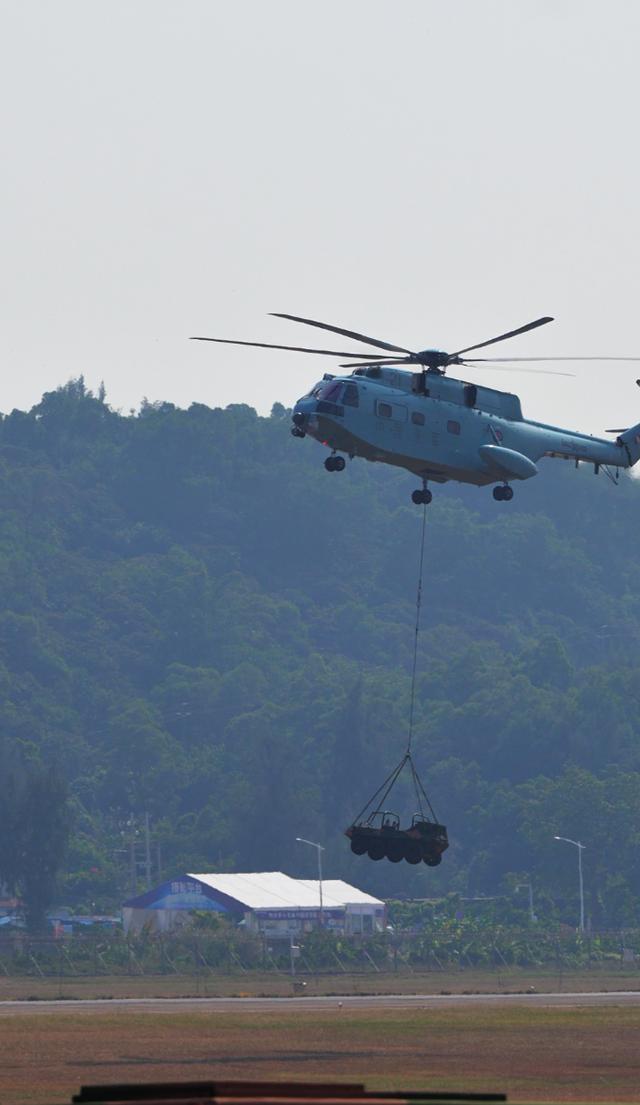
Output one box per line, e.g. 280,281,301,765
0,0,640,432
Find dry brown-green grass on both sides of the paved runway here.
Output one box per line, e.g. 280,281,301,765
0,965,640,1105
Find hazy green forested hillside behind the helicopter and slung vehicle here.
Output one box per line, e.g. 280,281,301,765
0,381,640,925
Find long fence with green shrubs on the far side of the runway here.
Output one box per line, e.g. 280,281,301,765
0,926,640,978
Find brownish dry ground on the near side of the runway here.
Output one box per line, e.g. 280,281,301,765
0,1000,640,1105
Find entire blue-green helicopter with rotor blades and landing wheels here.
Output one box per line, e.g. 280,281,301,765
192,312,640,505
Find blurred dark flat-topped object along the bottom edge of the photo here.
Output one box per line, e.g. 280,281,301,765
72,1082,506,1105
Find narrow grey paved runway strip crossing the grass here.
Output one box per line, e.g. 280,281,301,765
0,990,640,1017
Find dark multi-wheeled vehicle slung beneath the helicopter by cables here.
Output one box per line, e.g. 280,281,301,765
345,810,449,867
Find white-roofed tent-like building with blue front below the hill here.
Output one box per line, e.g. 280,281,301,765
123,871,386,937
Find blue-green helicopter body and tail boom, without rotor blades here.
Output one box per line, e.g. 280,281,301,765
293,367,640,497
